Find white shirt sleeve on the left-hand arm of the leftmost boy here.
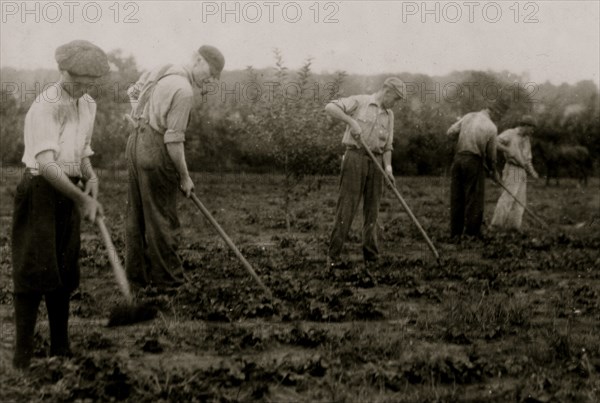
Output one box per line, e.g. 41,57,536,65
24,104,61,158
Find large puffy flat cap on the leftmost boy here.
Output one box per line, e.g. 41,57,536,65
54,40,110,77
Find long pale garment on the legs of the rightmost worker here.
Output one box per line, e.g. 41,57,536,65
492,164,527,229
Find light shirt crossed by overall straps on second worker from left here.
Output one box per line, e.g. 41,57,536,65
128,66,194,143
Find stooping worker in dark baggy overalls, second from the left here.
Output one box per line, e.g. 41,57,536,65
125,46,225,289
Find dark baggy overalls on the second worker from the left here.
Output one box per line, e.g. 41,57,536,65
125,119,183,287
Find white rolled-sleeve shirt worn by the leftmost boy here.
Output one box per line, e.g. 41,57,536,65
22,84,96,177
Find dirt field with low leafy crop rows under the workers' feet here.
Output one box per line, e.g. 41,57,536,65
0,172,600,402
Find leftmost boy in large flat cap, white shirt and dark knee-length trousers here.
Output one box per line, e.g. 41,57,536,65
12,40,109,368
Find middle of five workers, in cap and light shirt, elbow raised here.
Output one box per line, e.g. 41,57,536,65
325,77,406,268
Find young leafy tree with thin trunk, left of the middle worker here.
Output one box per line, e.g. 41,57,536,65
244,49,345,231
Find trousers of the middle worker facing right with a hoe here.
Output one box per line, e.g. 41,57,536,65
329,149,383,262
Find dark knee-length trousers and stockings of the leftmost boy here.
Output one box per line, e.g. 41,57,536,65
12,171,80,368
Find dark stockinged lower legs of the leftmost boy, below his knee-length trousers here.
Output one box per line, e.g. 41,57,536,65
13,291,71,368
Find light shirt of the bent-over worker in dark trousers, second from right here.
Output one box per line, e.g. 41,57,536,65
447,110,498,169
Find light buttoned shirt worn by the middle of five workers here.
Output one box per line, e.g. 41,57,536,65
332,94,394,154
